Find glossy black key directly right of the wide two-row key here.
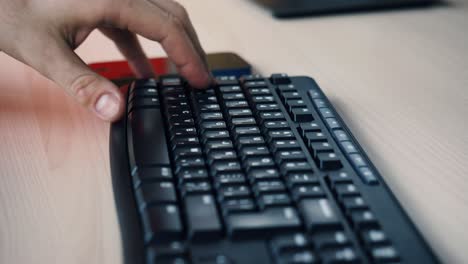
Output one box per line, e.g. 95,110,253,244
299,199,341,232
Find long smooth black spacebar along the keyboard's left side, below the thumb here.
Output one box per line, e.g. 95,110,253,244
128,108,170,166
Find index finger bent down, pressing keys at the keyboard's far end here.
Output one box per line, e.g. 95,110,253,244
110,0,212,88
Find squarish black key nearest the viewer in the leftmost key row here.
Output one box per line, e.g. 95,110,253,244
142,205,183,243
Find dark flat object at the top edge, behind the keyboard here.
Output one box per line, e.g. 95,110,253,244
255,0,434,17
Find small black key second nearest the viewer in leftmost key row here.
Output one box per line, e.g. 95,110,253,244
137,182,177,205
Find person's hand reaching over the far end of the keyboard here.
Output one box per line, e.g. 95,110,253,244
0,0,212,121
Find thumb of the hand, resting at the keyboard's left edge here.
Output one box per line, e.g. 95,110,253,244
15,35,124,121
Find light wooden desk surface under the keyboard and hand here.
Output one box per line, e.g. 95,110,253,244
0,0,468,264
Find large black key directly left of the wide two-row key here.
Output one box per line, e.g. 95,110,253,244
184,194,222,241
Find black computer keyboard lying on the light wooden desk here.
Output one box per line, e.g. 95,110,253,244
110,74,438,264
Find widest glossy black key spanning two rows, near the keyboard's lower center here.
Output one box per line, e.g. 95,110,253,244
226,207,301,238
